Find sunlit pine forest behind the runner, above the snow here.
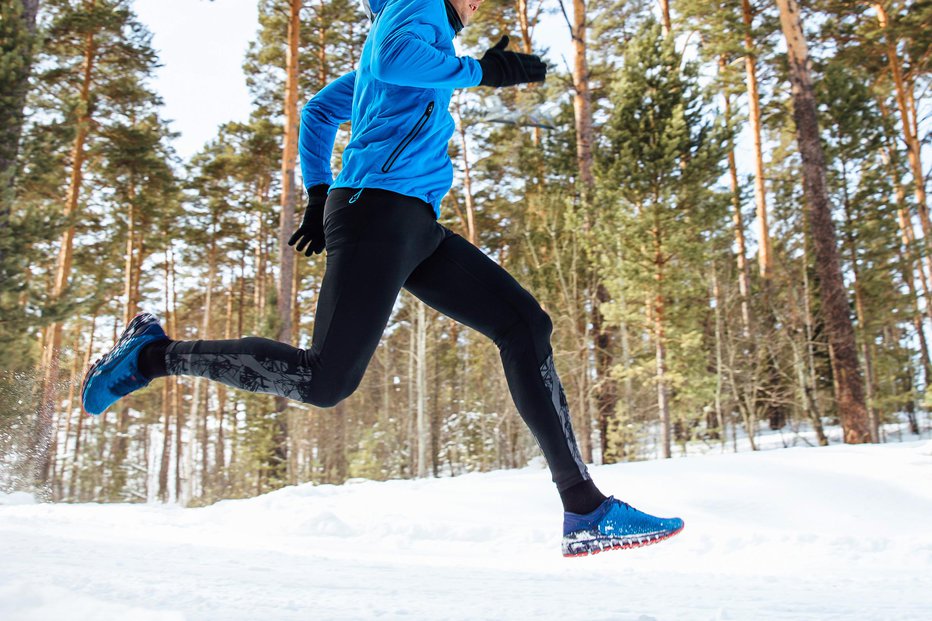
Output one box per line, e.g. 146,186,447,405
0,0,932,504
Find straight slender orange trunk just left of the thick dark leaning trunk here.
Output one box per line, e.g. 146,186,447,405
741,0,773,278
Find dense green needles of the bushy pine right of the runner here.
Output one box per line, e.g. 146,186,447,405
597,20,728,456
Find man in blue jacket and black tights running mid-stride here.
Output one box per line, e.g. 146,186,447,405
82,0,683,556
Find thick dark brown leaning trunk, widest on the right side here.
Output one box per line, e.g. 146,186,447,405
776,0,870,443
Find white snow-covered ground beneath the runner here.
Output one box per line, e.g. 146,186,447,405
0,441,932,621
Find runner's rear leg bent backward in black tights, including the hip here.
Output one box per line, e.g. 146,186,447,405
143,188,443,407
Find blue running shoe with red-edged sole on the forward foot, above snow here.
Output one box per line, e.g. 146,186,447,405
563,496,683,556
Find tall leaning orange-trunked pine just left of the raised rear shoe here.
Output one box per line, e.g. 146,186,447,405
24,0,168,482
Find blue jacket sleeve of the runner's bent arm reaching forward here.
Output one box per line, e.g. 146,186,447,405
372,0,482,88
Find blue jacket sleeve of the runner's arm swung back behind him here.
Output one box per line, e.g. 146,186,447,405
298,71,356,188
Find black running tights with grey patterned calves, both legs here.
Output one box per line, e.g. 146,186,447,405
165,188,589,491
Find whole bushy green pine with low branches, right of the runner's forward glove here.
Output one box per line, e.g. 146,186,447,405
599,21,727,457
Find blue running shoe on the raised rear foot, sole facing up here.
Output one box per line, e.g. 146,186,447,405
81,313,168,414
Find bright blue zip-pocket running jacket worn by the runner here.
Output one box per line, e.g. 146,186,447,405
299,0,482,217
